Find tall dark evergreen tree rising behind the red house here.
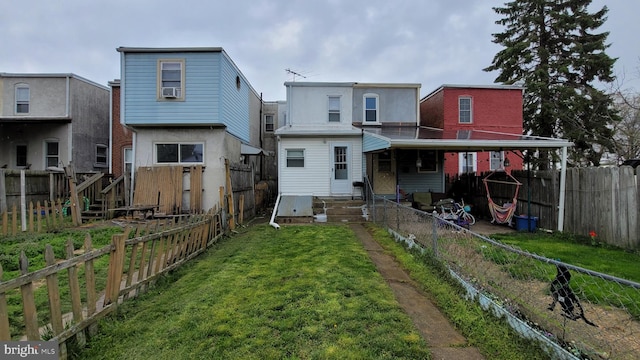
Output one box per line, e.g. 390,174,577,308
484,0,619,169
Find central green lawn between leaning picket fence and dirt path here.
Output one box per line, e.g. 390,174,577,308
81,225,429,359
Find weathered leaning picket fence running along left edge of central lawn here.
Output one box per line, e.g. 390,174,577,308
0,212,223,359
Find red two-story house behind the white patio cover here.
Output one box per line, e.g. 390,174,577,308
420,85,524,176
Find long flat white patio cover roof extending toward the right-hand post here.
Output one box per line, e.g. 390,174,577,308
363,126,573,152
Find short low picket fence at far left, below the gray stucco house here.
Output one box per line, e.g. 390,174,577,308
0,200,72,236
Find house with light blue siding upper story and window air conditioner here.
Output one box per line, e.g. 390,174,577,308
117,47,262,211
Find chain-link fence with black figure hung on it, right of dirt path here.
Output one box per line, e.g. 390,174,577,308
366,193,640,359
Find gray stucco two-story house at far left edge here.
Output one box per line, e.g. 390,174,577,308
0,73,109,172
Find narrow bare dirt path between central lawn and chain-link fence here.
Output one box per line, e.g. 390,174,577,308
351,224,484,360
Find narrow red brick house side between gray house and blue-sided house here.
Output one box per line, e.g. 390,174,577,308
109,80,133,178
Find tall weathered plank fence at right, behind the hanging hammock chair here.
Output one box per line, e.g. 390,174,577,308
449,166,640,249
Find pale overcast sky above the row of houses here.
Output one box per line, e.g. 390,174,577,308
0,0,640,100
